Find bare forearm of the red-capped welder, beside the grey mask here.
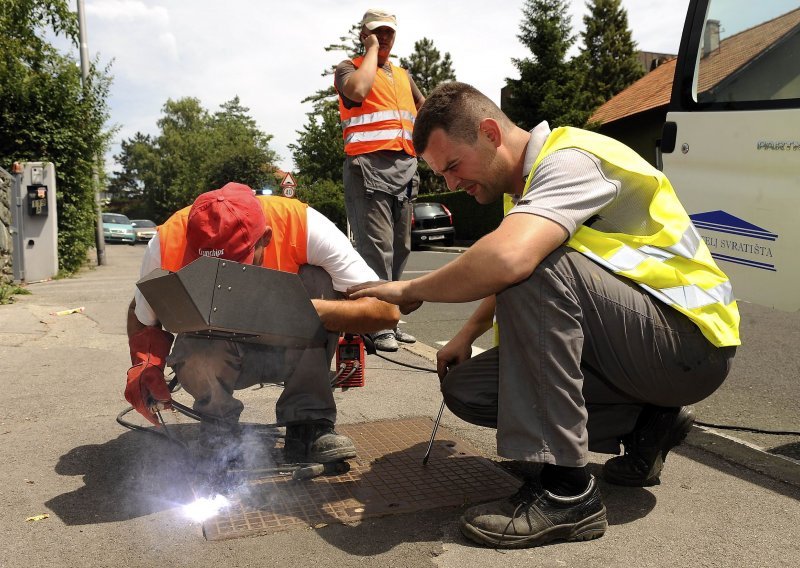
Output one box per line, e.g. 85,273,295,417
311,298,400,333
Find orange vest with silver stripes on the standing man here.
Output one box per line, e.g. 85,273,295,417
339,57,417,156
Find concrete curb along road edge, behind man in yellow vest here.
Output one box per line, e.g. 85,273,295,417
402,341,800,487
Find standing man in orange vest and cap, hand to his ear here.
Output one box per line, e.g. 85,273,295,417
334,10,425,351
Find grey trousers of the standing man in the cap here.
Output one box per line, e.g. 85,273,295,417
343,161,419,281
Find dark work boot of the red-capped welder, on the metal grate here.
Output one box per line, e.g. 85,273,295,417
283,420,356,463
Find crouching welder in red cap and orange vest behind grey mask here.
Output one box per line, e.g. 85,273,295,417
125,183,399,463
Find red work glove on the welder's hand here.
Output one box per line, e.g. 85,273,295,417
125,326,174,425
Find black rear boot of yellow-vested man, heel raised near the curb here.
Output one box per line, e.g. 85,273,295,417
603,406,694,487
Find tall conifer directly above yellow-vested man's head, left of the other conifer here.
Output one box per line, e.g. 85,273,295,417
503,0,586,130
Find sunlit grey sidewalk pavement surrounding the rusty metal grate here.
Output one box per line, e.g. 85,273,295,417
0,246,800,568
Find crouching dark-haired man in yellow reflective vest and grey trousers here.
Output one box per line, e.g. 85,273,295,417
350,82,740,548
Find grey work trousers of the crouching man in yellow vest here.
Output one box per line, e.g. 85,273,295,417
442,247,736,467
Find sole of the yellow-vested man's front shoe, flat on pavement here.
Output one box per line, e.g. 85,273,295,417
461,506,608,548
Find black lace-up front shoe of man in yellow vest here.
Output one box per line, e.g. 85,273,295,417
461,477,608,548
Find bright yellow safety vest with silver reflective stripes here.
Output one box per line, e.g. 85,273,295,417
496,127,741,347
